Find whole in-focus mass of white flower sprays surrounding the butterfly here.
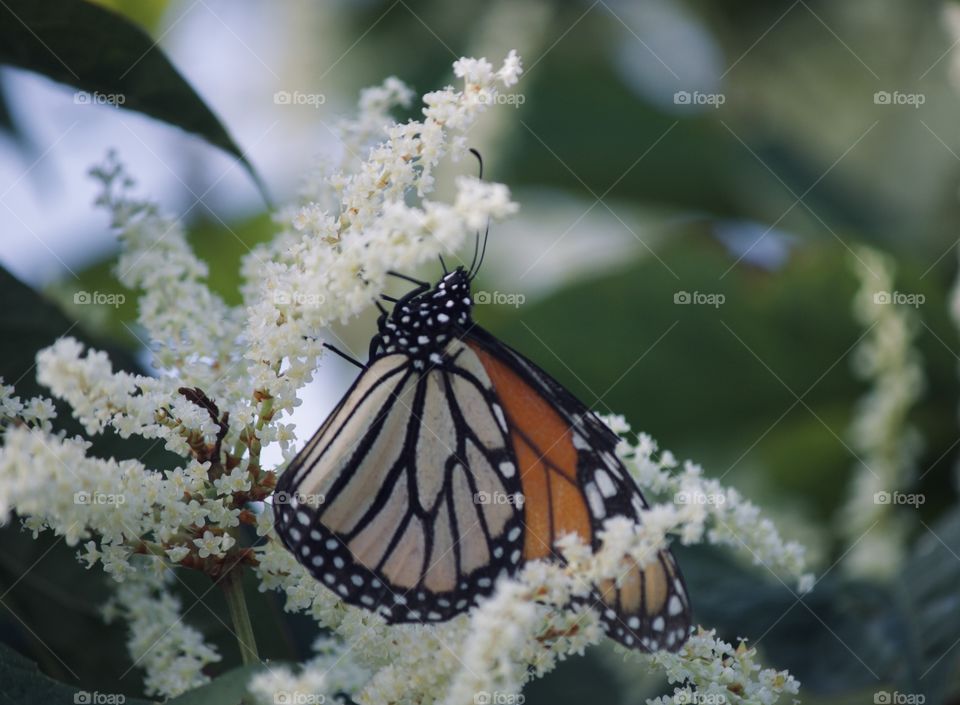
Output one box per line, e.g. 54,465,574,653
0,52,812,705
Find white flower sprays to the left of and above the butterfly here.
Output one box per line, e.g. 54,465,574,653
0,54,520,695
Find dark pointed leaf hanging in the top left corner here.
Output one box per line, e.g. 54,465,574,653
0,0,267,199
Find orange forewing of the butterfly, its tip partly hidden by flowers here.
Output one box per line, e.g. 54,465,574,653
467,327,690,651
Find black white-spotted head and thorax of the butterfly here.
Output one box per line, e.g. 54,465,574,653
375,267,473,369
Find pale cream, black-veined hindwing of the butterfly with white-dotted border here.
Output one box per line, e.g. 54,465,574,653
276,350,524,622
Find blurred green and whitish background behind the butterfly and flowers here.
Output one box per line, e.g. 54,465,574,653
0,0,960,704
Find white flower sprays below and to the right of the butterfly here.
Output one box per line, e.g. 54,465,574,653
256,418,813,705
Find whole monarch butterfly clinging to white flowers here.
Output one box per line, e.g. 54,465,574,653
275,194,690,651
